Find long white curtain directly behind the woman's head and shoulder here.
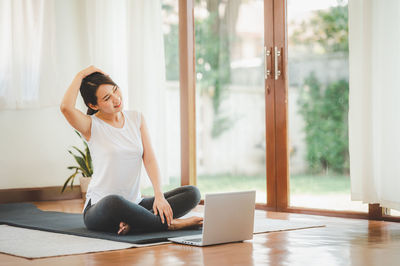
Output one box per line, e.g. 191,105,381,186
86,0,168,185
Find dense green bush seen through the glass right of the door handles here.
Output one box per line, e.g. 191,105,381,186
298,73,349,174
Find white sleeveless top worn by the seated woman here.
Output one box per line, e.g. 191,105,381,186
82,110,143,212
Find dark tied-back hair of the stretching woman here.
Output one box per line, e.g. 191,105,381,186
79,72,117,115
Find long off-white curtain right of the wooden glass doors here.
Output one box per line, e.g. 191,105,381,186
349,0,400,210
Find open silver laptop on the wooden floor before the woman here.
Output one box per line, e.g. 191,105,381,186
168,190,256,246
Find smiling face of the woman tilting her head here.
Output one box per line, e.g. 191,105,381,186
92,84,123,113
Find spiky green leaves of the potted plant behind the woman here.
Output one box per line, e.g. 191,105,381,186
61,130,93,193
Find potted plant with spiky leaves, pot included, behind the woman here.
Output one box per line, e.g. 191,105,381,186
61,130,93,200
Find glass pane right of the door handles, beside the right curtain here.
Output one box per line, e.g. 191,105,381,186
287,0,368,212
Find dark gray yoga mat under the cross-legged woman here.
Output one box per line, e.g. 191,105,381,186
0,203,201,244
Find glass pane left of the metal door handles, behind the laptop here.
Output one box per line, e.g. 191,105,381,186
194,0,267,203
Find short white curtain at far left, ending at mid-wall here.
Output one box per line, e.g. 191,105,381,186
0,0,59,110
